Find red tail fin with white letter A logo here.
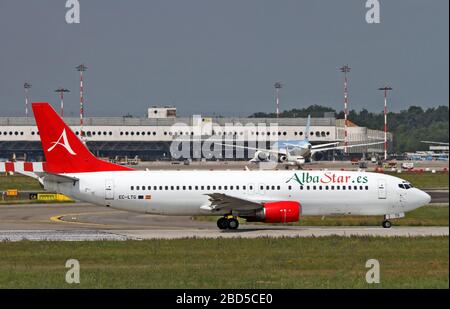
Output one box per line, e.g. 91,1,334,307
33,103,131,173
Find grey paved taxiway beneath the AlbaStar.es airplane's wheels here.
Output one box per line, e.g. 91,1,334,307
0,202,449,241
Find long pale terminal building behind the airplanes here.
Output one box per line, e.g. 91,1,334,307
0,107,392,161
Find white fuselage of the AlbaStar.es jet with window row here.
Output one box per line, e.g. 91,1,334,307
44,171,429,216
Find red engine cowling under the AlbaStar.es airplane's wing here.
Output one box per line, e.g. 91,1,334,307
246,201,301,223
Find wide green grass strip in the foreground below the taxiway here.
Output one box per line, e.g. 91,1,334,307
0,237,449,289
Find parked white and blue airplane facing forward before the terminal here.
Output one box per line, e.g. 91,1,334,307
217,115,384,167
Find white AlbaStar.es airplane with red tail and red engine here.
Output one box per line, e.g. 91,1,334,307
19,103,431,230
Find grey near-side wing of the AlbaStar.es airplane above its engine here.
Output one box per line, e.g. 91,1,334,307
203,193,263,212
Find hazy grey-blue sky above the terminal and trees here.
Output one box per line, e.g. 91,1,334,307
0,0,449,116
